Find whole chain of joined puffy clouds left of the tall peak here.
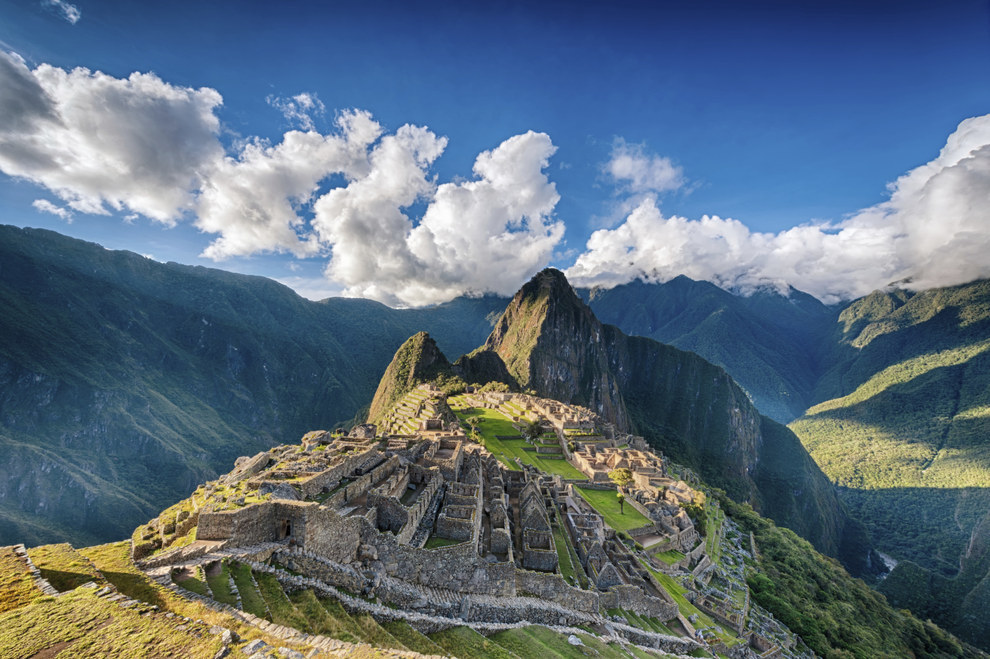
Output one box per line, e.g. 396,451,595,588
0,52,564,305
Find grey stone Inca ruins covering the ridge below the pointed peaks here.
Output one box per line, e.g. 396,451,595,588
134,387,792,656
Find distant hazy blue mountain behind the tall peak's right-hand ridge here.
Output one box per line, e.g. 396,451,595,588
578,275,835,423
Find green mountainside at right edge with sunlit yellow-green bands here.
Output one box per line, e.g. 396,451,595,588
791,280,990,647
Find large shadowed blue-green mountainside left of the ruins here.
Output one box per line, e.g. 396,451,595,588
0,227,504,545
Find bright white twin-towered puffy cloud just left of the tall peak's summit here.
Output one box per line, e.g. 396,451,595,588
314,127,564,305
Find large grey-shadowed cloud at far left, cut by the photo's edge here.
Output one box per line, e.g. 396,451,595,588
0,52,223,224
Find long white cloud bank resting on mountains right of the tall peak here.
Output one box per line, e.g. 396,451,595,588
567,115,990,302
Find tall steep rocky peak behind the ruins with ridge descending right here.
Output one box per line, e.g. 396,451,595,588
469,269,868,571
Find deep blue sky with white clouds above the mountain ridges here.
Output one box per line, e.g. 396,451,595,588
0,0,990,304
